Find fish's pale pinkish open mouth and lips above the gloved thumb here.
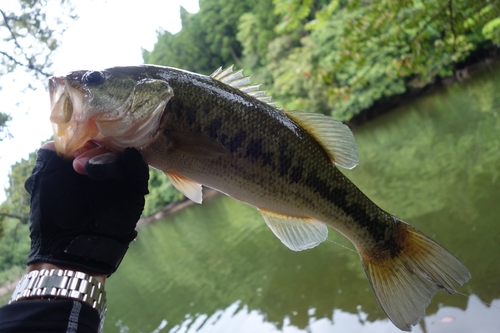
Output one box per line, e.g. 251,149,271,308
49,76,99,159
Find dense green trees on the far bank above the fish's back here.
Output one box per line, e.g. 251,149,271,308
145,0,500,121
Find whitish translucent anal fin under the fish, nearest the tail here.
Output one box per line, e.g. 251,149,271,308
260,209,328,251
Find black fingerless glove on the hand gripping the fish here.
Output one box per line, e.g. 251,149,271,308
24,148,149,275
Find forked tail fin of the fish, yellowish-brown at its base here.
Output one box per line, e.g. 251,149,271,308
360,218,471,331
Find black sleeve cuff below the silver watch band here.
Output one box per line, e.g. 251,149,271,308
0,300,100,333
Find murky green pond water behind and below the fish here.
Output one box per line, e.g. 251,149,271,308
105,63,500,333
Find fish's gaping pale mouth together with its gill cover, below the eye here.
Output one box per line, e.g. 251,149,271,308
49,76,173,159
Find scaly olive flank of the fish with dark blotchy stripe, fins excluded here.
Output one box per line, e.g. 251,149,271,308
148,69,398,246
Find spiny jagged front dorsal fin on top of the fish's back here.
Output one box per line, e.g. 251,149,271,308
210,65,276,108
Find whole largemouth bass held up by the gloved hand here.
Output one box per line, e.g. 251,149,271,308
49,65,471,331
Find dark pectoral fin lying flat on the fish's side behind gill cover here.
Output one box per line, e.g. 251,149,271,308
167,131,229,158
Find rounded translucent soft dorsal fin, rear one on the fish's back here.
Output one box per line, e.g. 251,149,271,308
285,111,358,169
